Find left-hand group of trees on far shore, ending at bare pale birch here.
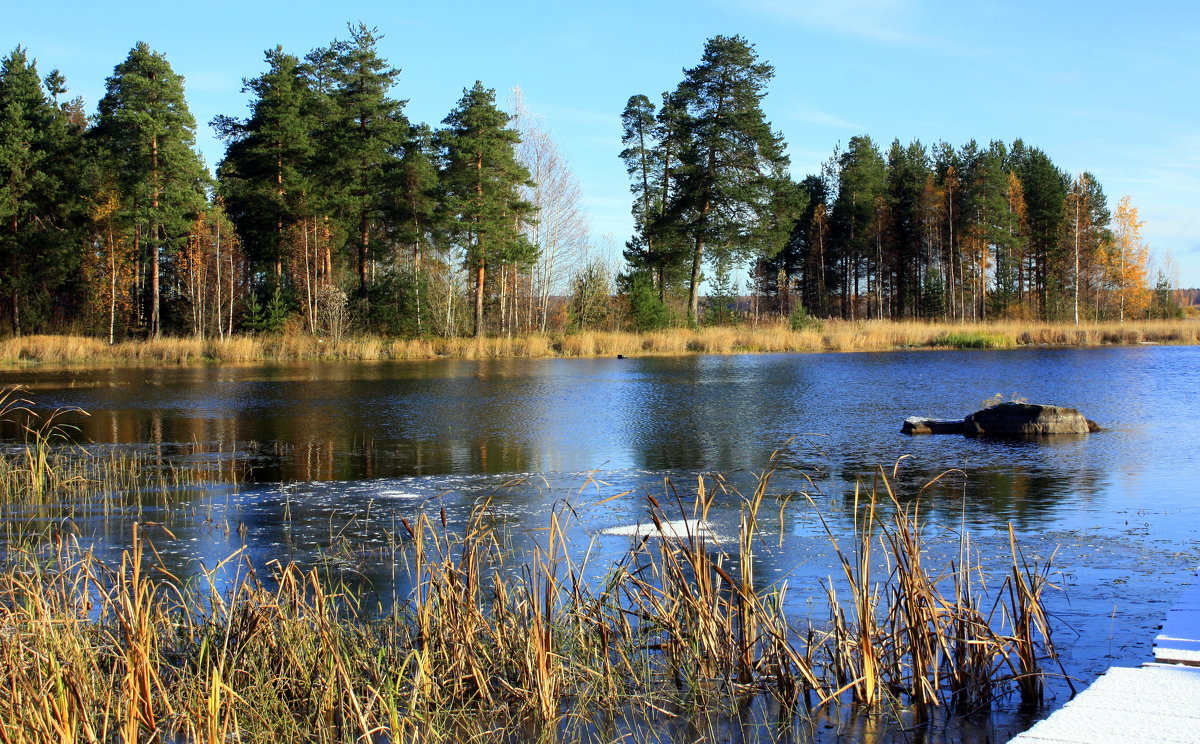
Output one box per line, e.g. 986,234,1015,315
0,25,588,340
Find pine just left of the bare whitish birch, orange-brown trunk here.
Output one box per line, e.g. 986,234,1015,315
440,82,536,336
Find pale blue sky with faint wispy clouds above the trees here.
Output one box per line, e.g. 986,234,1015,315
0,0,1200,287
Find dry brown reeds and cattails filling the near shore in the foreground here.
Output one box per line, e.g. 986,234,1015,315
0,444,1054,744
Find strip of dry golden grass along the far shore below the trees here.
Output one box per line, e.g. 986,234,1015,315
0,320,1200,367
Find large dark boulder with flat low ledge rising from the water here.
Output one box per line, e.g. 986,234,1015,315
900,402,1102,437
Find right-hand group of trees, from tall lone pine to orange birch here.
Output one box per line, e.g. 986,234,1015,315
622,36,1171,323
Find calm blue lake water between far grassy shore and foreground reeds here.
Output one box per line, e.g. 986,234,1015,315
0,346,1200,740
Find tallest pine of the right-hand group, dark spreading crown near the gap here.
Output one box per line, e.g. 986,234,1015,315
664,36,790,323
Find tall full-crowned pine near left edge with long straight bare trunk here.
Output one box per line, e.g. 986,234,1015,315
92,42,209,336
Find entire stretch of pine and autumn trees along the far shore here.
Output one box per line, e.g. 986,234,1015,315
0,25,1178,343
